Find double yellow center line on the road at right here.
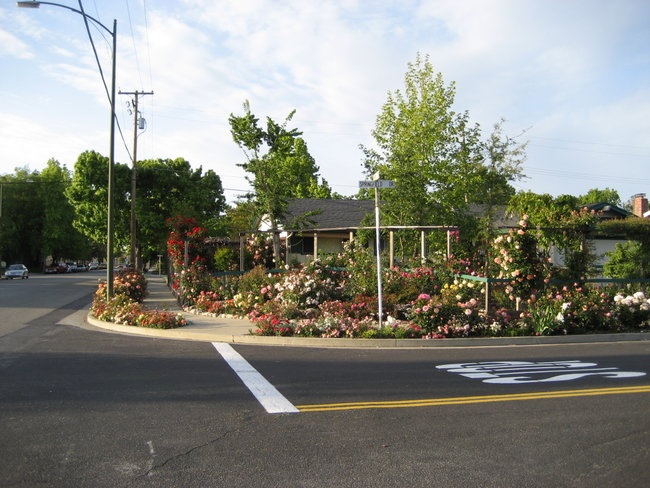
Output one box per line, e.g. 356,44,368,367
296,385,650,412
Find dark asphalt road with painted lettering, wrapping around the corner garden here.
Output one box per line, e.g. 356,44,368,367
0,273,650,488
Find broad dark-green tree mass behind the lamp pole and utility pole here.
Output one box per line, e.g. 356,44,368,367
66,151,225,261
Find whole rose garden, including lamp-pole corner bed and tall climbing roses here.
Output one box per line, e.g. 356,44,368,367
92,215,650,339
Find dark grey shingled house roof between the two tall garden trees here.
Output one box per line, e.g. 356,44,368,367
283,198,375,230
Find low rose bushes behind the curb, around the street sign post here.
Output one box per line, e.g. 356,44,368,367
181,262,650,339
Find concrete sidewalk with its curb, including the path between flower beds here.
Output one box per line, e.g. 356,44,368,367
87,275,650,349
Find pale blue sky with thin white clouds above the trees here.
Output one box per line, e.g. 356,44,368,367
0,0,650,202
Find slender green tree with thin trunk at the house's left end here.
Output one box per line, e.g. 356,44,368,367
228,101,331,262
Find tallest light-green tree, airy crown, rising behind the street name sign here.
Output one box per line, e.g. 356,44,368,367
361,54,524,257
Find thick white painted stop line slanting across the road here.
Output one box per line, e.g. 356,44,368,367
212,342,299,413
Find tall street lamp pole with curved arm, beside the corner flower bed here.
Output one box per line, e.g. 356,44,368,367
16,0,117,299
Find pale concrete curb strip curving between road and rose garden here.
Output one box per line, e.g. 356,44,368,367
87,314,650,349
